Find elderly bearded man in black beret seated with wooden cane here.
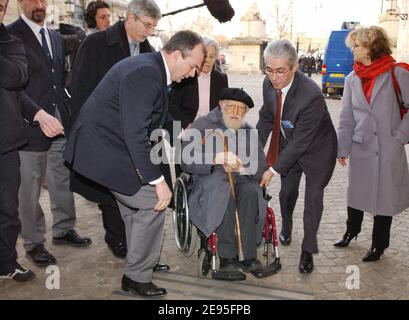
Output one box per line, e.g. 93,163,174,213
175,88,281,280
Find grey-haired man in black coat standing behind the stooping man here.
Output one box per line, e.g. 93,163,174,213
70,0,161,262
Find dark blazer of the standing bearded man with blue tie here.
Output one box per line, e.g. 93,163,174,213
7,18,70,151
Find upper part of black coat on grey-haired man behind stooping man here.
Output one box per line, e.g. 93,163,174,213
70,21,155,117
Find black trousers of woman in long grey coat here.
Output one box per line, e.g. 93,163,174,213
347,207,392,250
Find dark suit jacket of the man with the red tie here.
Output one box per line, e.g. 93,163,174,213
257,71,337,176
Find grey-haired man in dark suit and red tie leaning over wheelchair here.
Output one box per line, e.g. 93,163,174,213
257,40,337,273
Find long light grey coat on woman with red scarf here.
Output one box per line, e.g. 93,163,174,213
337,67,409,216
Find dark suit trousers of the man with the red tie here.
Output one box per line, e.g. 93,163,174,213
279,157,335,253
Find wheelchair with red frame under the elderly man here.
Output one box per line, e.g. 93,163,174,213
172,172,281,279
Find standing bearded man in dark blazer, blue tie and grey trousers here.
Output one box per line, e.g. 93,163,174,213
8,0,91,267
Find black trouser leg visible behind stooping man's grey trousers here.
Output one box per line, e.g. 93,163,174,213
98,204,126,246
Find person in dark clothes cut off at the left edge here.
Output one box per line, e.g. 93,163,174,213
0,0,35,282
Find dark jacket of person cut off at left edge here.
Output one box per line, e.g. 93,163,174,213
0,24,27,154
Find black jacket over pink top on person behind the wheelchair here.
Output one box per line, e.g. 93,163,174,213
169,70,228,129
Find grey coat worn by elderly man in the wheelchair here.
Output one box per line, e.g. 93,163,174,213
181,108,268,243
